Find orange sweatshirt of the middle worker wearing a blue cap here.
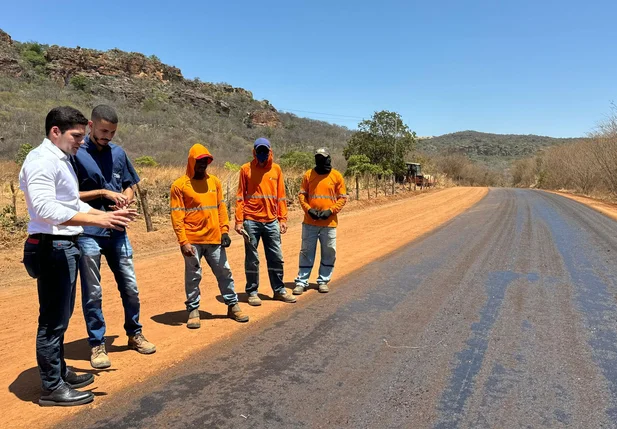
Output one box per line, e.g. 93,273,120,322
236,150,287,223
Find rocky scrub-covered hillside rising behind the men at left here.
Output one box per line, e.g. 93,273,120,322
0,30,350,163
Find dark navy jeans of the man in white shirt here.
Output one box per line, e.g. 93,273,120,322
36,240,80,391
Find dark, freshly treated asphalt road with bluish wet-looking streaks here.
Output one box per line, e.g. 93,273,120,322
64,189,617,428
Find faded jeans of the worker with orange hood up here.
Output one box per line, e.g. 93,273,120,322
184,244,238,312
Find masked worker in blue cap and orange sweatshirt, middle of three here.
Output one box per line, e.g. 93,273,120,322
235,137,296,306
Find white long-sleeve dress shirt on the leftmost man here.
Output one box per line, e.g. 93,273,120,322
19,139,92,235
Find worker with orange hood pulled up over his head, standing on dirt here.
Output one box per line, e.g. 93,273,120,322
170,144,249,329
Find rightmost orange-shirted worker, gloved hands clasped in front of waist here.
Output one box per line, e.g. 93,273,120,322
293,148,347,295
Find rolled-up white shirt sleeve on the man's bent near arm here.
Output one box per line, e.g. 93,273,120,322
24,159,78,225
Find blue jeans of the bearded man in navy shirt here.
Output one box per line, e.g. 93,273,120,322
79,234,141,347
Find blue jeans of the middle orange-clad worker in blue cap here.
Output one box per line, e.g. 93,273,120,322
244,220,285,295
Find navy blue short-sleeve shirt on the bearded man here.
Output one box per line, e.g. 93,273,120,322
73,136,139,237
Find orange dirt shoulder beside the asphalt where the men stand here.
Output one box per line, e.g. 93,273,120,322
0,188,487,428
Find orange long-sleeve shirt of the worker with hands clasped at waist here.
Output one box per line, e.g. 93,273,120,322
298,169,347,228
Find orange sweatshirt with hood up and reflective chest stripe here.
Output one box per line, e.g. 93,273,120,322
169,144,229,246
